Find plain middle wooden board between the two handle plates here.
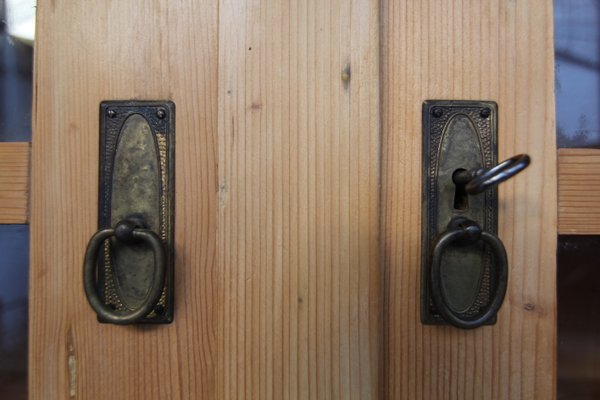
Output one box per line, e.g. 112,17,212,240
217,0,381,400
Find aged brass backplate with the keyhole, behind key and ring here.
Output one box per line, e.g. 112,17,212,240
421,100,498,325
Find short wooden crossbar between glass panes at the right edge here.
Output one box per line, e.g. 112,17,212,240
558,149,600,235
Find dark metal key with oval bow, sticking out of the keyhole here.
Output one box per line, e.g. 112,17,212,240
452,154,531,194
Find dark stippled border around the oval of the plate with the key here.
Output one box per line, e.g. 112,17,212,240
421,100,498,325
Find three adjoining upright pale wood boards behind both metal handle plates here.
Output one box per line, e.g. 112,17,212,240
29,0,556,400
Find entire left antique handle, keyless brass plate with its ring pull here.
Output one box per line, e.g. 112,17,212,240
84,101,175,324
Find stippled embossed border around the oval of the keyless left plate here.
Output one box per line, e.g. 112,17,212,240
98,100,175,324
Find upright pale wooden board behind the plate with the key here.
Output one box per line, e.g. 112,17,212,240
381,0,557,400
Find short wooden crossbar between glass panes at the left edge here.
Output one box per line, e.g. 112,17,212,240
0,142,31,224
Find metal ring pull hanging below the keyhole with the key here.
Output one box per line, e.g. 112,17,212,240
430,219,508,329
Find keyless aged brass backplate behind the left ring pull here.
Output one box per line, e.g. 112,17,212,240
98,101,175,323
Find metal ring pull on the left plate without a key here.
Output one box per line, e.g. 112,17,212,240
83,219,166,325
